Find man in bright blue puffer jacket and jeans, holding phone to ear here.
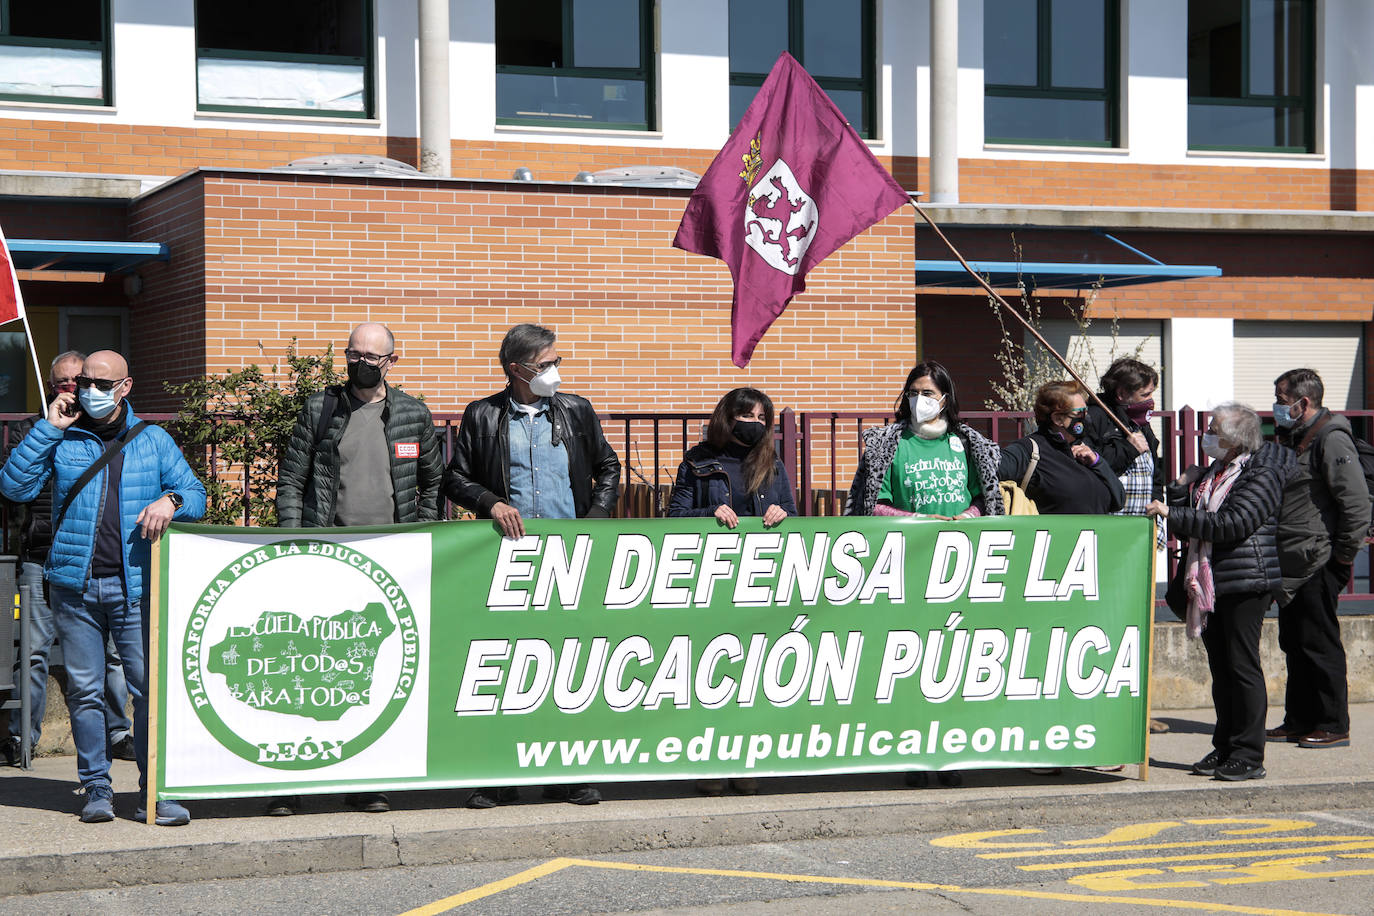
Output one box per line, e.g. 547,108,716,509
0,350,205,827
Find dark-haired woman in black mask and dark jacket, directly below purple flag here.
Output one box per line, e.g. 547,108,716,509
668,389,797,527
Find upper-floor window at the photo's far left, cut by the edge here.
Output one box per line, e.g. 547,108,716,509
0,0,110,104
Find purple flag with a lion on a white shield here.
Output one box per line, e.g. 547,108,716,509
673,51,908,368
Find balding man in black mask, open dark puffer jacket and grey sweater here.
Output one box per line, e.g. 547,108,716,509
276,321,444,816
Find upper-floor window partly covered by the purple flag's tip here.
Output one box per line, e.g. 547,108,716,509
730,0,875,137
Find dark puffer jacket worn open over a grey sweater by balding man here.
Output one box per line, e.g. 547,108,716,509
276,386,444,527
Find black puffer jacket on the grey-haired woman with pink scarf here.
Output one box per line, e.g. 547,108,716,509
1168,442,1297,598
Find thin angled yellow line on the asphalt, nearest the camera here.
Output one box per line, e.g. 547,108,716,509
401,858,1340,916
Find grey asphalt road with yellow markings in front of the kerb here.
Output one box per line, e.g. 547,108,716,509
10,808,1374,916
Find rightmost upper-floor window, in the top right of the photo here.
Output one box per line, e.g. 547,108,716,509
1189,0,1316,152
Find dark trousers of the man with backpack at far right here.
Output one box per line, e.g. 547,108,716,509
1279,563,1351,733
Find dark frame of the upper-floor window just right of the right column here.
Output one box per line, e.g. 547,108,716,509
982,0,1121,150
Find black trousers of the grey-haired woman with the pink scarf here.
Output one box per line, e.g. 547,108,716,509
1202,595,1270,765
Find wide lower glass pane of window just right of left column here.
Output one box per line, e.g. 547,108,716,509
496,73,647,126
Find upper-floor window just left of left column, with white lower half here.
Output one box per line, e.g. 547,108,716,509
195,0,372,118
